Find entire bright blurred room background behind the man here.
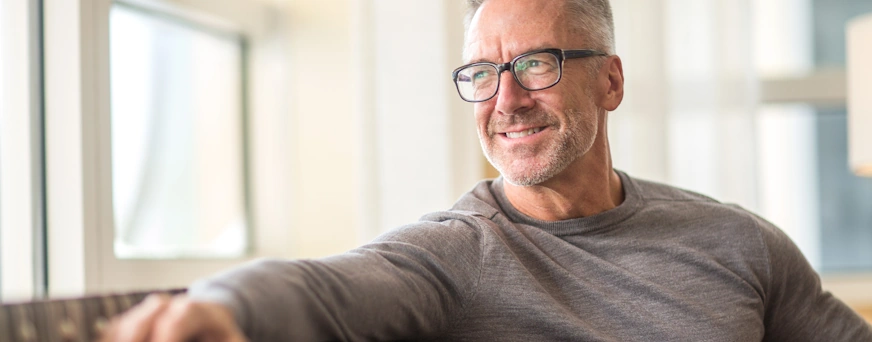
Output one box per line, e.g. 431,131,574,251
0,0,872,320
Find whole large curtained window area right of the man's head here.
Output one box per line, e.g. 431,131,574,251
609,0,872,308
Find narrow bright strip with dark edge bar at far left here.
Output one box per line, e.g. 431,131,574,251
0,1,46,301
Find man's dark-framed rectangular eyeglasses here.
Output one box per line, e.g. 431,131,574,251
451,49,609,102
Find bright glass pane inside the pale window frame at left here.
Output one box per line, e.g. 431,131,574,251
110,5,248,258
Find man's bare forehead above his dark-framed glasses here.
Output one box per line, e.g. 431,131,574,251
463,0,567,62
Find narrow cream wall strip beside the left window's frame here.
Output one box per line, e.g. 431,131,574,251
284,0,356,257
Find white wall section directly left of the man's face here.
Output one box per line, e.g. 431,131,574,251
360,0,481,238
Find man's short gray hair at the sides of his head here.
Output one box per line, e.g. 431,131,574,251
464,0,615,54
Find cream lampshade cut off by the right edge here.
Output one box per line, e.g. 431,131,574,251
847,14,872,177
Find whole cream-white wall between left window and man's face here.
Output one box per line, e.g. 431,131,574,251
283,0,482,257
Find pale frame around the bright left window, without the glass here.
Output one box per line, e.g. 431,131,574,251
44,0,289,296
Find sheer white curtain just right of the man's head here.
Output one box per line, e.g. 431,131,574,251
610,0,758,209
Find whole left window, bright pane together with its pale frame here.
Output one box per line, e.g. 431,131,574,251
43,0,289,296
